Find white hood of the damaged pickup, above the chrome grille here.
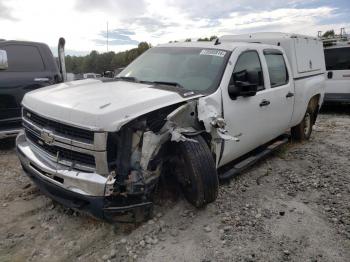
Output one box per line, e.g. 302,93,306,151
22,80,200,131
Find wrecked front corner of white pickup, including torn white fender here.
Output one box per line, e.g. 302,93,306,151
103,94,235,221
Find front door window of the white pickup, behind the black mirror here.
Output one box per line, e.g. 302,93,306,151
230,51,264,91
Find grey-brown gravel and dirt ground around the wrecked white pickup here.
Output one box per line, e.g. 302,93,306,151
0,107,350,262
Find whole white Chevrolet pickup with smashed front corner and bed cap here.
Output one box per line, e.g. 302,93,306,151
17,33,325,220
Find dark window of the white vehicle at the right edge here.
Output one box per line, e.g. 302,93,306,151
324,47,350,70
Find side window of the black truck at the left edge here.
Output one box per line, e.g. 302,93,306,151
2,45,45,72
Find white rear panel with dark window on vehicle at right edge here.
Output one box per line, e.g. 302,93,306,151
324,46,350,101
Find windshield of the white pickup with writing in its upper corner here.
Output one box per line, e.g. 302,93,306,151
118,47,230,93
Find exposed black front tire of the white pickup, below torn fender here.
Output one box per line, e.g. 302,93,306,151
175,136,219,208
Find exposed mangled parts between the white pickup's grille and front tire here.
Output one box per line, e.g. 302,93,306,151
104,101,205,220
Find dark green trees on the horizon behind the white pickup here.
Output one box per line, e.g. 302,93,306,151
66,36,217,74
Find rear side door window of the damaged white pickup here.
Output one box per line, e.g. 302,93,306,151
264,50,288,88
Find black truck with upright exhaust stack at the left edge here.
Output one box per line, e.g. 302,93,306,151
0,39,64,139
